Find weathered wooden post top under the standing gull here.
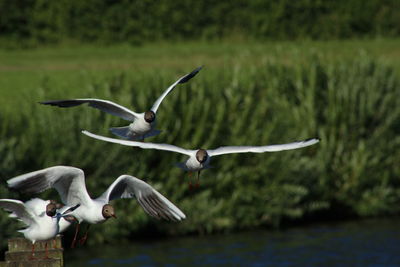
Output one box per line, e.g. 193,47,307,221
0,238,64,267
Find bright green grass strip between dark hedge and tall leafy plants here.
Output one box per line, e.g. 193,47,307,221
0,39,400,114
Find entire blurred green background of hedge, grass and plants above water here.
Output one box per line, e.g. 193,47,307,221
0,0,400,252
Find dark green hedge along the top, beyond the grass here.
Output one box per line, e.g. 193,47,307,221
0,0,400,47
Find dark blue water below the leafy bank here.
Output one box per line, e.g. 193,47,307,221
65,219,400,267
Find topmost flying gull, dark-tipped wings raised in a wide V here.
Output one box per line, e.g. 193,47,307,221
40,67,202,141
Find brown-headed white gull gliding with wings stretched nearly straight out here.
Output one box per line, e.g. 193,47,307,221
82,130,320,186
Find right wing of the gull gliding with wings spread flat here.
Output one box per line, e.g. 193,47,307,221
207,138,319,157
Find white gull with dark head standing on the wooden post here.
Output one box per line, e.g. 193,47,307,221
0,198,79,259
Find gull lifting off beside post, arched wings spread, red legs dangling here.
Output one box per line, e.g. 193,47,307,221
7,166,186,247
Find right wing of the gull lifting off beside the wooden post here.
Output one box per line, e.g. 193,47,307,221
97,175,186,221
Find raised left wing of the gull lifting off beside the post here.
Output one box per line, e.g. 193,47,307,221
7,166,92,206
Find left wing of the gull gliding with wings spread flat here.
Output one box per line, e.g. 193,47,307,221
82,130,196,156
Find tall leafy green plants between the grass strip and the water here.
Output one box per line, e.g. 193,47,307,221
0,54,400,250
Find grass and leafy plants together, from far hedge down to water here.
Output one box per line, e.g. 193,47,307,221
0,39,400,251
